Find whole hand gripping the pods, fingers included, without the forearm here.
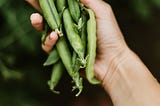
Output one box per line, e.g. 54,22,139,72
27,0,128,82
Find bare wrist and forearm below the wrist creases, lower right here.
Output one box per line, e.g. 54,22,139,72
102,49,160,106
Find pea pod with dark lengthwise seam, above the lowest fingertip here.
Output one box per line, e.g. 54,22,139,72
39,0,61,33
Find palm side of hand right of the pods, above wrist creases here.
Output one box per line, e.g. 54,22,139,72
81,0,128,83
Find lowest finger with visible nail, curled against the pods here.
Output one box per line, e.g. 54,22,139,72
42,31,58,53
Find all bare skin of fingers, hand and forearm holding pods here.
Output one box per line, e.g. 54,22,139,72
27,0,160,106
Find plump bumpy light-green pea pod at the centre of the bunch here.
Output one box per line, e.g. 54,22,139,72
63,9,86,66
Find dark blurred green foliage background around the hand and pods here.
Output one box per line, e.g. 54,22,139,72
0,0,160,106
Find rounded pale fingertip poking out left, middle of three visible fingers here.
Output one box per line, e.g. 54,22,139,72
30,13,43,32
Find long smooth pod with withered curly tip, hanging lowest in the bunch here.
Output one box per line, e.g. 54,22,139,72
56,36,83,96
